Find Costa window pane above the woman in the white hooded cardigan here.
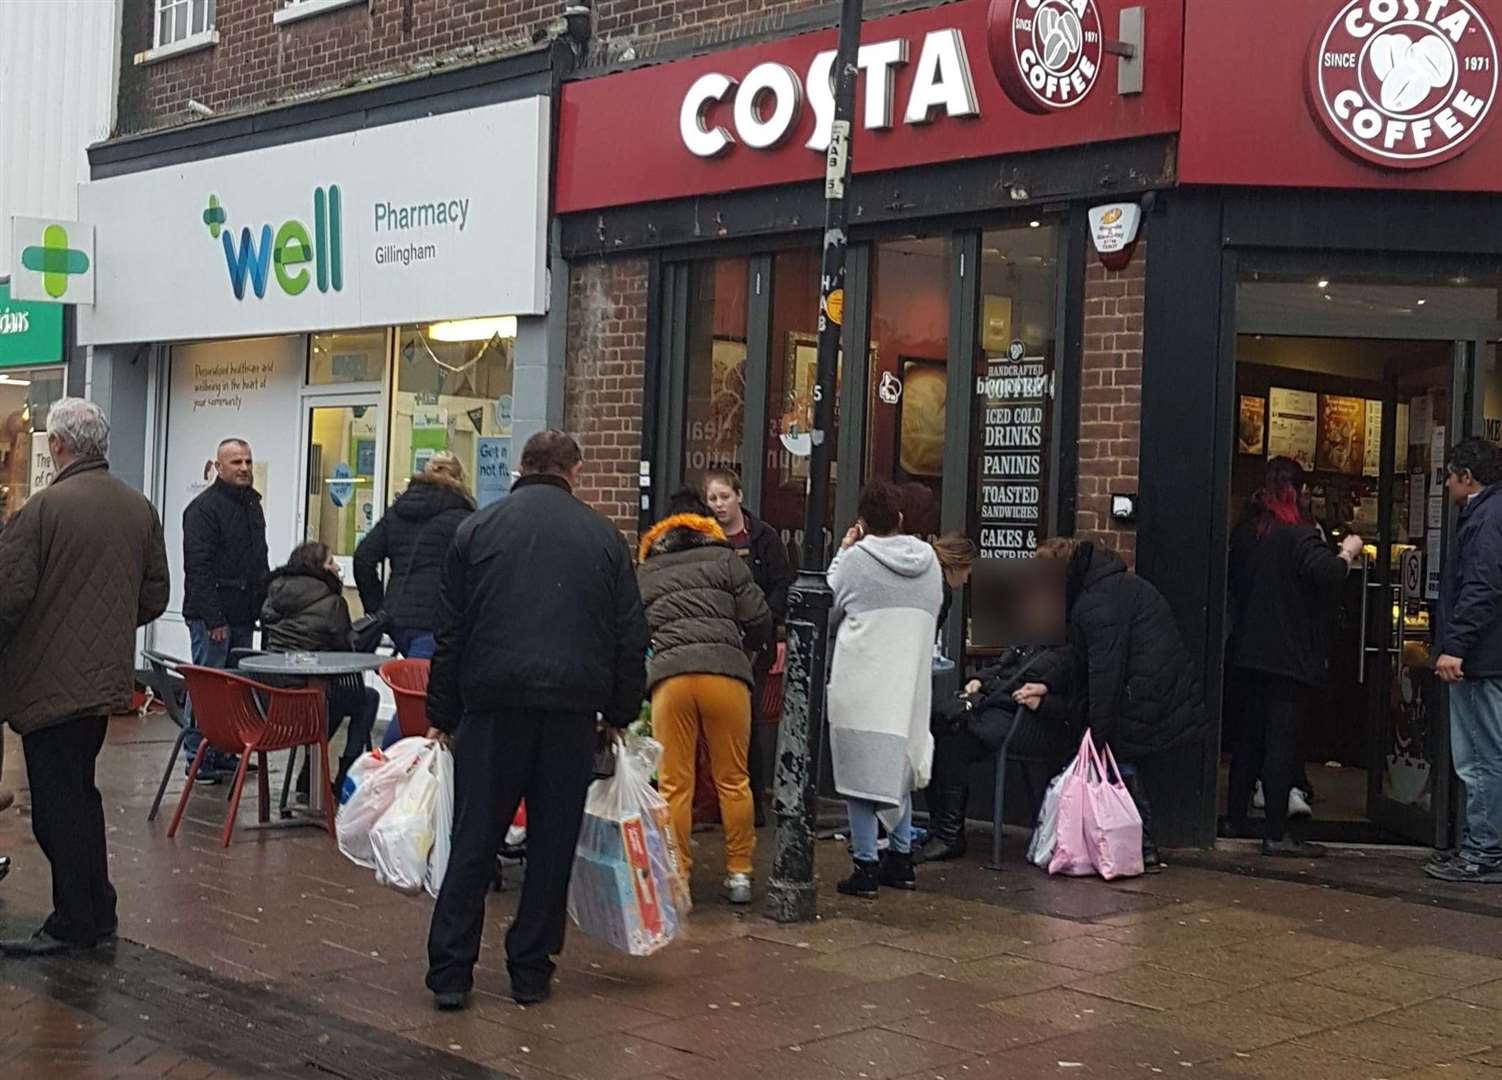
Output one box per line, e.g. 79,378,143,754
865,237,949,536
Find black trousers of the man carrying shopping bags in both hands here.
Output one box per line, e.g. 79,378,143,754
427,710,595,993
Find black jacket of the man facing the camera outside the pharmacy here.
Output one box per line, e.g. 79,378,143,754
183,481,270,629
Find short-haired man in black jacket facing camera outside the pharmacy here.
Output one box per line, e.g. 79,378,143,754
183,439,270,781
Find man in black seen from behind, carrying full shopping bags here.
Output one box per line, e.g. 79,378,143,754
427,430,647,1009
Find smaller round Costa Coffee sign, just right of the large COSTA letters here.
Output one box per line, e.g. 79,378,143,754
987,0,1105,113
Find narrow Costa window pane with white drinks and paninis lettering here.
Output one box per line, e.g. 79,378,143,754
969,225,1059,559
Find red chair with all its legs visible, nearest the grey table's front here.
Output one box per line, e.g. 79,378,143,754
167,664,333,847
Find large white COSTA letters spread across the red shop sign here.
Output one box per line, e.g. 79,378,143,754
677,30,981,158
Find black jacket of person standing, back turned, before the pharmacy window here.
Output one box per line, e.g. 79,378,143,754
354,473,475,631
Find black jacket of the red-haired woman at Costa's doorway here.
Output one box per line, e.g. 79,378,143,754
1230,517,1350,686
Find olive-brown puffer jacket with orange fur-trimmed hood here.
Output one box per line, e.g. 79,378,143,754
637,514,772,689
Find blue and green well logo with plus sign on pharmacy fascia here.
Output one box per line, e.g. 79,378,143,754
203,183,344,300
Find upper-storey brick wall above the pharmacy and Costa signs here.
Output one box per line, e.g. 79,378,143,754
116,0,859,135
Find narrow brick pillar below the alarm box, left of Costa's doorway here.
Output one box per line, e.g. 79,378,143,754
1074,246,1148,563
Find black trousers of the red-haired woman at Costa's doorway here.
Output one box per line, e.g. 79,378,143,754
1226,671,1310,840
